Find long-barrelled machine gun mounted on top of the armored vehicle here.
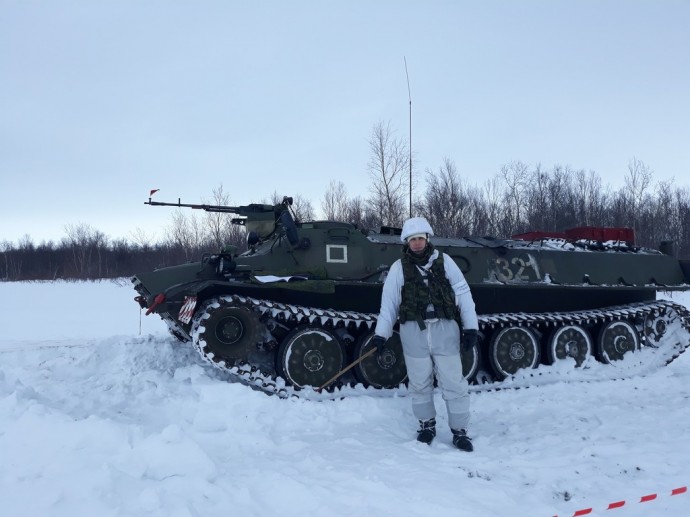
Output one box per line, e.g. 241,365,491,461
144,196,299,247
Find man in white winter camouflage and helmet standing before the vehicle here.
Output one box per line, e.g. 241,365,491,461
372,217,479,452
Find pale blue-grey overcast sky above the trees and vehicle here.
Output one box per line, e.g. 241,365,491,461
0,0,690,243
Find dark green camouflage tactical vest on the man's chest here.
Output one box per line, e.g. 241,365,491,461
398,253,459,330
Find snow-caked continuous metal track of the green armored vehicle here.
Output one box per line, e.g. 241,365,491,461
191,295,690,400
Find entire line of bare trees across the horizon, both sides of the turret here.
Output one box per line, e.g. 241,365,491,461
0,122,690,281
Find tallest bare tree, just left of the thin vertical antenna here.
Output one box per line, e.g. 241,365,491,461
368,122,408,226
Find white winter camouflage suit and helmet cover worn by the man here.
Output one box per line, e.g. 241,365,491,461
375,217,479,430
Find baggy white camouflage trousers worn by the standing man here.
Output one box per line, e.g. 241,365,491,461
400,319,470,429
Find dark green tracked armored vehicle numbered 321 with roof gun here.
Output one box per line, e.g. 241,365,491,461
132,197,690,395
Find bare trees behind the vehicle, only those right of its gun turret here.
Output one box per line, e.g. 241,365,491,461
321,123,690,258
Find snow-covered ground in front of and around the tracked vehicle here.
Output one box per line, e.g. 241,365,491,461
0,281,690,517
